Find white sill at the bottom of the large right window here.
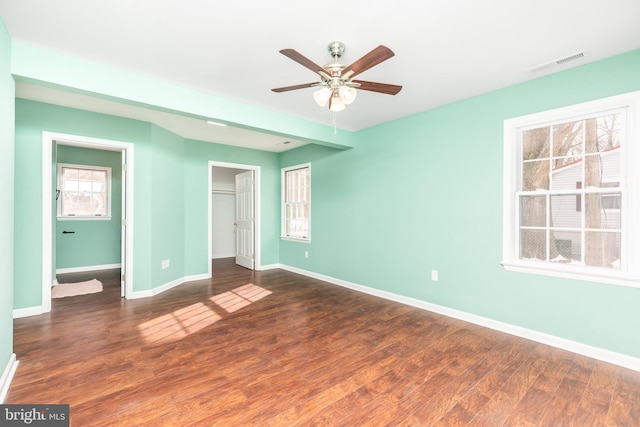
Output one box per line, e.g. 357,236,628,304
501,261,640,288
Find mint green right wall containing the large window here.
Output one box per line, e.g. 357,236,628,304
280,51,640,357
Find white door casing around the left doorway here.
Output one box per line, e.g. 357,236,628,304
42,131,134,313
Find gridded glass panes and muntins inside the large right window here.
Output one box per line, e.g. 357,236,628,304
518,111,624,269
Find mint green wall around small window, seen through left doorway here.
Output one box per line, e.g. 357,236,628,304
55,144,122,269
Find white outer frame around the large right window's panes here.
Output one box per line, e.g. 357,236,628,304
502,91,640,287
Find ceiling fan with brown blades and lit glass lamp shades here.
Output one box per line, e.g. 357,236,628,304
271,42,402,111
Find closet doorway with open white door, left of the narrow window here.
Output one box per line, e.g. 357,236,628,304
208,161,260,276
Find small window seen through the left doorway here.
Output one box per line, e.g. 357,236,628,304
56,163,111,219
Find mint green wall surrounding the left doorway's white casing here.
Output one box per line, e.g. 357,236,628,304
14,99,151,309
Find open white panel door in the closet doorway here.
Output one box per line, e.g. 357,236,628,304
235,171,255,270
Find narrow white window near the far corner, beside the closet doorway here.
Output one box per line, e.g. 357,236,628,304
282,163,311,242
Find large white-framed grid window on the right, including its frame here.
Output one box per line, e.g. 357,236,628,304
503,92,640,286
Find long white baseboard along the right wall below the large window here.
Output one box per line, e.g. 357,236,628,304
280,265,640,372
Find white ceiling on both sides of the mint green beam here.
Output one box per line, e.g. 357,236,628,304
0,0,640,151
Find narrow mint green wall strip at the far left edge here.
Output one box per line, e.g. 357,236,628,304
0,18,15,372
